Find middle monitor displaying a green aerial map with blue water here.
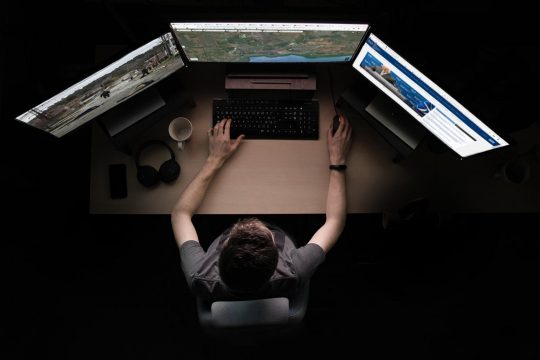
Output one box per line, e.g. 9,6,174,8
170,22,369,63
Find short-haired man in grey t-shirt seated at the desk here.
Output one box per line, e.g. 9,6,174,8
171,116,352,301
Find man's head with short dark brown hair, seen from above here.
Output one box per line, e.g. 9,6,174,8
219,218,278,291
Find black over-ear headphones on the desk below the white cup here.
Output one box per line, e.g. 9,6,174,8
135,140,181,187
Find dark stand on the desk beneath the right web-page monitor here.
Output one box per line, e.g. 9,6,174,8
338,84,427,162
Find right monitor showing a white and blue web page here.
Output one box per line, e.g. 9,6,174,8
353,33,508,158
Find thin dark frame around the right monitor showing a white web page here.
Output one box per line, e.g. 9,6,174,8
351,31,514,160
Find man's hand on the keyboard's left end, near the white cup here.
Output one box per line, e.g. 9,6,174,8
208,119,245,165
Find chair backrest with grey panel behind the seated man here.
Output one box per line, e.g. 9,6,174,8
197,283,309,343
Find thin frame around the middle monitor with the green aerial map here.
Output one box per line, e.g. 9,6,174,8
169,19,372,66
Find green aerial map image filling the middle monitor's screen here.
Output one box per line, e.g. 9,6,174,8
175,30,365,62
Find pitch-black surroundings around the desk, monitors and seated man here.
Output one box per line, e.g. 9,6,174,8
0,0,540,359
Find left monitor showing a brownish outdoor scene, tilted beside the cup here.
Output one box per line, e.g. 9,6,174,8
17,33,184,137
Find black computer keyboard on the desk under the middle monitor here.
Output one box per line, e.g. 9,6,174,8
212,99,319,140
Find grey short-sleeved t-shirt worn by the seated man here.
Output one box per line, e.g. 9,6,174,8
180,224,325,301
